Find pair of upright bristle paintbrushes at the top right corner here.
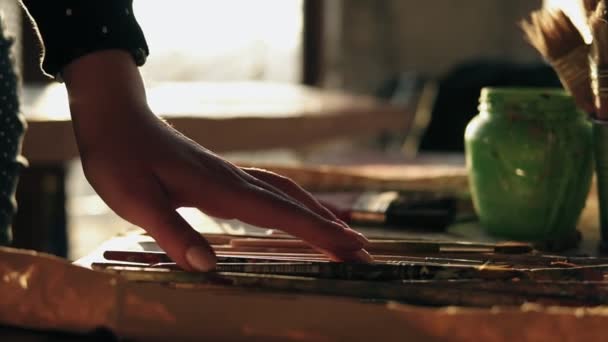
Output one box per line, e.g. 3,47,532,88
521,0,608,116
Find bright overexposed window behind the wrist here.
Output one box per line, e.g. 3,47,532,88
134,0,303,82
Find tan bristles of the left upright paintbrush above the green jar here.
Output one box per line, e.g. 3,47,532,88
521,9,585,61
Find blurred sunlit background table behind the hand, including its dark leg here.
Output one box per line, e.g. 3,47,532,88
14,82,413,256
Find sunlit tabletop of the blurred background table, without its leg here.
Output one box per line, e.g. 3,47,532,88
22,82,413,163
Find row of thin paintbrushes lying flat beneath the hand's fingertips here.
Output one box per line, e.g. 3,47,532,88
92,238,608,282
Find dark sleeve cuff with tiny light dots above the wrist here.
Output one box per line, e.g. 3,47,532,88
21,0,149,77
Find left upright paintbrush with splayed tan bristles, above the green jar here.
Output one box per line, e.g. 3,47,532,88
520,9,595,113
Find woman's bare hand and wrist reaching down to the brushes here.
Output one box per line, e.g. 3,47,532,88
63,50,371,271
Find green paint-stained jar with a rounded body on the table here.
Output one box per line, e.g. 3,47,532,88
465,88,592,242
